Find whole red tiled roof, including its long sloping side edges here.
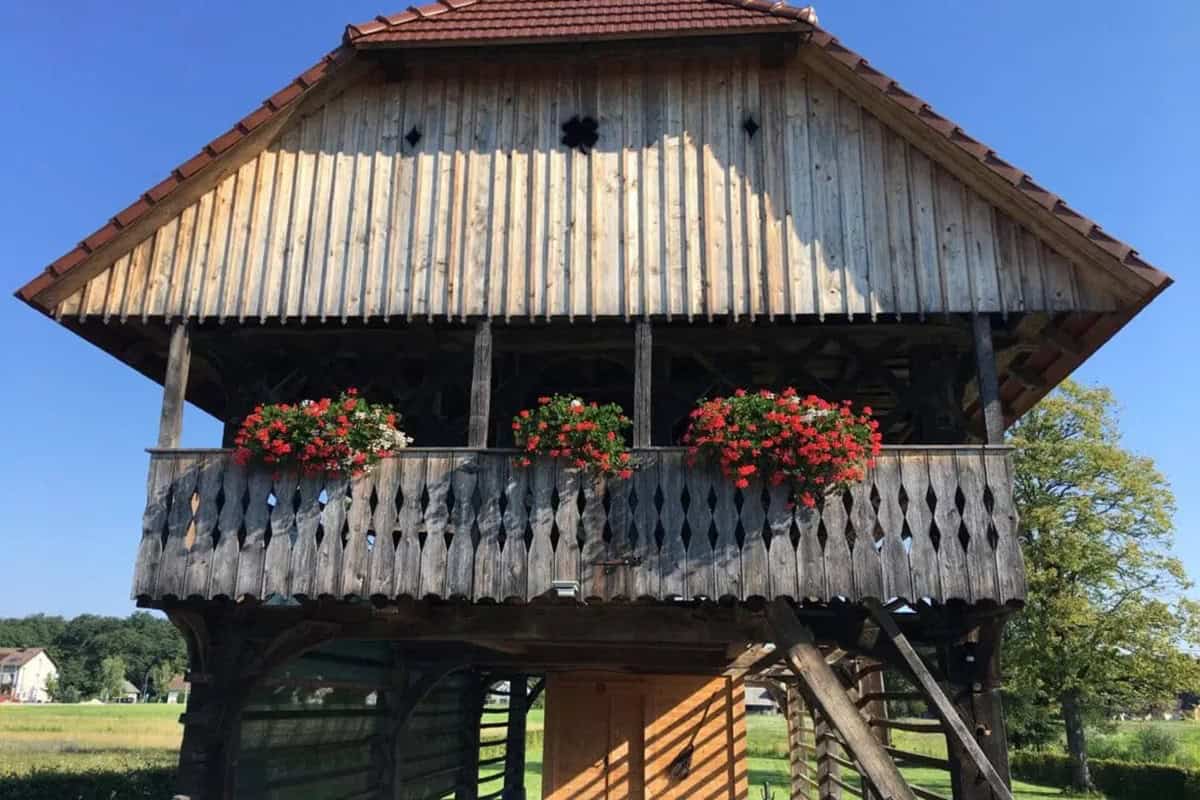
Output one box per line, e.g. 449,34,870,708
17,0,1170,311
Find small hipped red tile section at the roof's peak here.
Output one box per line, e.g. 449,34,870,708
346,0,816,47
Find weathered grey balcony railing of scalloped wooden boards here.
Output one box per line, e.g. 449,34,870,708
133,446,1025,606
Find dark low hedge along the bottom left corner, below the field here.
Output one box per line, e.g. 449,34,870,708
0,768,175,800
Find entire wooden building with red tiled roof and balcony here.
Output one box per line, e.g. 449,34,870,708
11,0,1170,800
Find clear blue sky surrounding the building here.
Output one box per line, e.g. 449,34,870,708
0,0,1200,615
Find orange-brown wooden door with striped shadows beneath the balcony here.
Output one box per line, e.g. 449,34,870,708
542,673,748,800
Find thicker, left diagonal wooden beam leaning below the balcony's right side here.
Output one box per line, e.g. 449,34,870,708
767,599,916,800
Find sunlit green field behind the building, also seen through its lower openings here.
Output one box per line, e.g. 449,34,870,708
0,705,1161,800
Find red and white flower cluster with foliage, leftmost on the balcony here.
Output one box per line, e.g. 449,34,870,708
234,389,412,475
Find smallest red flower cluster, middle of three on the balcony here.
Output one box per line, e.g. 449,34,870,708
512,395,632,479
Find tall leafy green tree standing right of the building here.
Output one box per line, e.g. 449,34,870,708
1006,381,1200,790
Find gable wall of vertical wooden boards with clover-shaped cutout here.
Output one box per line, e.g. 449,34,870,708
58,59,1115,321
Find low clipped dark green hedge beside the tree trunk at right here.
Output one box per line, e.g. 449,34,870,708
1009,751,1200,800
